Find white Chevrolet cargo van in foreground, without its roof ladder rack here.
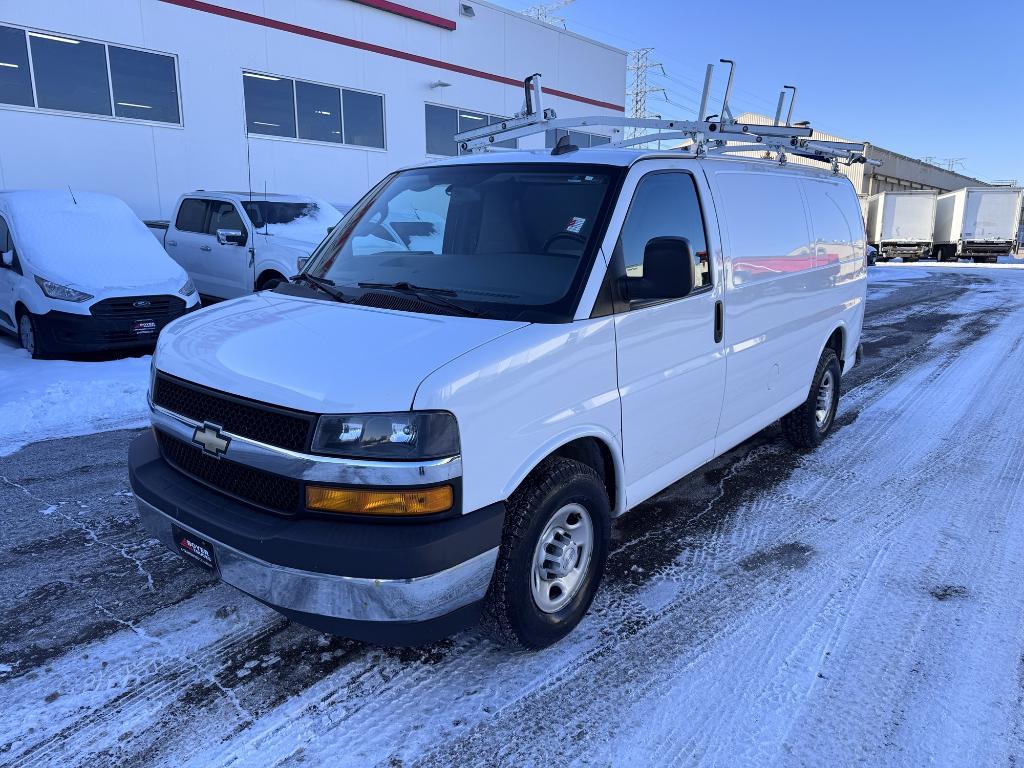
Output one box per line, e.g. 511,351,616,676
130,148,866,647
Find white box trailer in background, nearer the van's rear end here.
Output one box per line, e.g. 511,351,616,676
865,189,936,261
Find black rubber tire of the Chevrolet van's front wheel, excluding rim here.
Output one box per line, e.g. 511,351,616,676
483,457,611,648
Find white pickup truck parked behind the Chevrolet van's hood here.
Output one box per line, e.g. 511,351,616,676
146,189,342,299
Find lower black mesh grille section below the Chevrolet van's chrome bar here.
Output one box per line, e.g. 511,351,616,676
157,430,302,514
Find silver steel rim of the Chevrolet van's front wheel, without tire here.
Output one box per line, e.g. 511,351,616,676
530,504,594,613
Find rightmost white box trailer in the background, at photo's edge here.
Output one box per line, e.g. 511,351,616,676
935,186,1024,262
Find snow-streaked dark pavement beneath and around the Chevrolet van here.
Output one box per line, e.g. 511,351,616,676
0,265,1024,766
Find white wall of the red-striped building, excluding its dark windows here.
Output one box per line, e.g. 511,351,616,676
0,0,626,218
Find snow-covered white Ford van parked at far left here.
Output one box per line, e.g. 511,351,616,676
0,189,199,357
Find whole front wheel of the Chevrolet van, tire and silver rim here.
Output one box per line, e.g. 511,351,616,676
484,457,611,648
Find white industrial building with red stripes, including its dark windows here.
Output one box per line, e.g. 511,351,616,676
0,0,627,218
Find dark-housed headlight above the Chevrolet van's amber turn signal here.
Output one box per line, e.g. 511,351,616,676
313,411,459,461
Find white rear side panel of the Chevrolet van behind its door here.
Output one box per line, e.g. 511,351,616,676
706,161,866,454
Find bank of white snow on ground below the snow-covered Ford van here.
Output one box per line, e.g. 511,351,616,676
0,336,150,456
